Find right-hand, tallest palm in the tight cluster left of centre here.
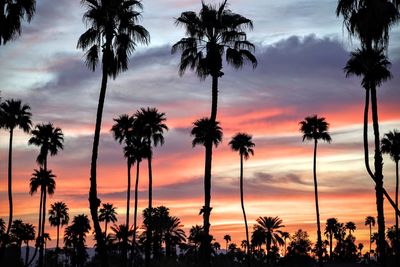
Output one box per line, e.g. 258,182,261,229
135,107,168,267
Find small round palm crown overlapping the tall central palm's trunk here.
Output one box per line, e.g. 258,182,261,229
190,118,223,147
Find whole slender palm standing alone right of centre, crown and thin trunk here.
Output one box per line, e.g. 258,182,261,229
300,115,332,266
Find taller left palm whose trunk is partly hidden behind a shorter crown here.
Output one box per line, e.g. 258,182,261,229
28,123,64,266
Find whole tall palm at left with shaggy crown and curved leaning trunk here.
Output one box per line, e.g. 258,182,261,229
77,0,150,266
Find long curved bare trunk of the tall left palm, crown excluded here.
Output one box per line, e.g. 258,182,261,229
89,48,110,267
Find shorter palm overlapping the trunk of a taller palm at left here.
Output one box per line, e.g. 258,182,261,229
29,167,56,266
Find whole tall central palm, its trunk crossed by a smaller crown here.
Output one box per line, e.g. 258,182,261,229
171,0,257,266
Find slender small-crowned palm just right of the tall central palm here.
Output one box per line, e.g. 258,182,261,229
229,133,255,262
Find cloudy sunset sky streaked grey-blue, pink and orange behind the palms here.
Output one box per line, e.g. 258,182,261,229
0,0,400,251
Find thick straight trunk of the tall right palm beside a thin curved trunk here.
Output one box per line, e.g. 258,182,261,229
371,87,386,267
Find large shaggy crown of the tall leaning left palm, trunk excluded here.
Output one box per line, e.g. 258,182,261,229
77,0,150,78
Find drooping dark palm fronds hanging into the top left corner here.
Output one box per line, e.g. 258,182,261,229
0,0,36,45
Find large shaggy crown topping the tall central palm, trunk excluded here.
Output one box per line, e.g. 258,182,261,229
172,0,257,79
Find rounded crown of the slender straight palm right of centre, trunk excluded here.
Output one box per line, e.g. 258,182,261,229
300,115,332,143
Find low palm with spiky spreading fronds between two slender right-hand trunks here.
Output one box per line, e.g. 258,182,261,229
257,217,285,254
